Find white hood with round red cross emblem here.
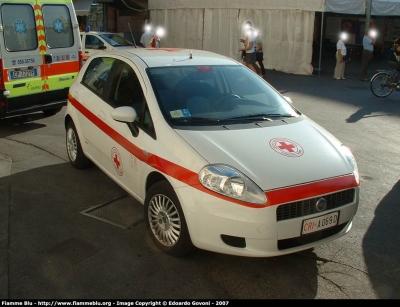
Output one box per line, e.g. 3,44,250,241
175,118,352,190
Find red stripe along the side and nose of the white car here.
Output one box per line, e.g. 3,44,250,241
68,94,359,208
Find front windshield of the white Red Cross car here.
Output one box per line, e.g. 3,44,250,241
147,65,300,126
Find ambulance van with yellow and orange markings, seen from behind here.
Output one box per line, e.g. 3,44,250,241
0,0,82,119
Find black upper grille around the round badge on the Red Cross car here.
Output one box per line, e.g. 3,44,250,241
276,189,355,221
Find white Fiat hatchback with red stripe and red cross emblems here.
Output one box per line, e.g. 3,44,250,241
65,48,360,257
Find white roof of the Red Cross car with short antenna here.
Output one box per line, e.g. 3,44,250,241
102,47,240,67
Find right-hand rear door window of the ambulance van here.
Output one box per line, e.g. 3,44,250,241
42,4,74,49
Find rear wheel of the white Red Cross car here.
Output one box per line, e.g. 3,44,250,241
66,121,90,169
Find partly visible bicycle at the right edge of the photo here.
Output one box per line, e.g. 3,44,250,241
370,61,400,98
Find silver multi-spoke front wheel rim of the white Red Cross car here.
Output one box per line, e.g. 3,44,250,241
148,194,182,247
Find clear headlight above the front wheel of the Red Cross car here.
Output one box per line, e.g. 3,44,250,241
199,164,267,205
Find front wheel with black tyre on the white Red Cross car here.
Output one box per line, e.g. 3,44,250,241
144,181,195,257
